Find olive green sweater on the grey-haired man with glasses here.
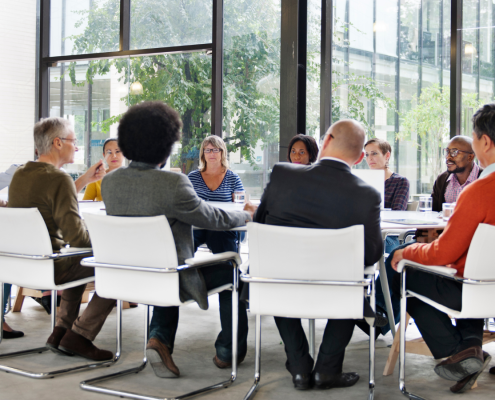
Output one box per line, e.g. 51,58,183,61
8,161,91,251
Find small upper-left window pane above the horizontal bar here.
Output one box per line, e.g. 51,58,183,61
50,0,120,57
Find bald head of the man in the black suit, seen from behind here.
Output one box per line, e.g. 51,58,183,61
320,119,366,165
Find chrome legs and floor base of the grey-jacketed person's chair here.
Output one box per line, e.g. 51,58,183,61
79,266,239,400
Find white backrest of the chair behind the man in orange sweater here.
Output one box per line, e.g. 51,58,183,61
461,224,495,318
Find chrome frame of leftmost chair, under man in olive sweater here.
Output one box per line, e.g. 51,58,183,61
0,251,122,379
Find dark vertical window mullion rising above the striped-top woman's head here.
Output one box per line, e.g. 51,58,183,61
211,0,223,137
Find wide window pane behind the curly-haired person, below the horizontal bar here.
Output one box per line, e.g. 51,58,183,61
50,53,211,174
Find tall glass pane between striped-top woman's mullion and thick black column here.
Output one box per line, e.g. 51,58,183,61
223,0,281,198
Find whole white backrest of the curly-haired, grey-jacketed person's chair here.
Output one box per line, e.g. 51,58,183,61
84,213,181,306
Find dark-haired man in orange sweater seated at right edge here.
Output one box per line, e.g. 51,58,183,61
392,104,495,393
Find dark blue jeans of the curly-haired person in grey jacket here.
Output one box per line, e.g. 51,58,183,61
150,264,248,362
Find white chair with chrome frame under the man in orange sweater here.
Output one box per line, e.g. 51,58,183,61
397,224,495,400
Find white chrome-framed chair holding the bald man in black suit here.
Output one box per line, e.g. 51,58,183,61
241,223,376,400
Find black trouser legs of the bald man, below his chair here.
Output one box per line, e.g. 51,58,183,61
275,317,355,375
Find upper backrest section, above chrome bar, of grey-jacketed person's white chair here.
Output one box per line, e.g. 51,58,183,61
84,213,178,268
